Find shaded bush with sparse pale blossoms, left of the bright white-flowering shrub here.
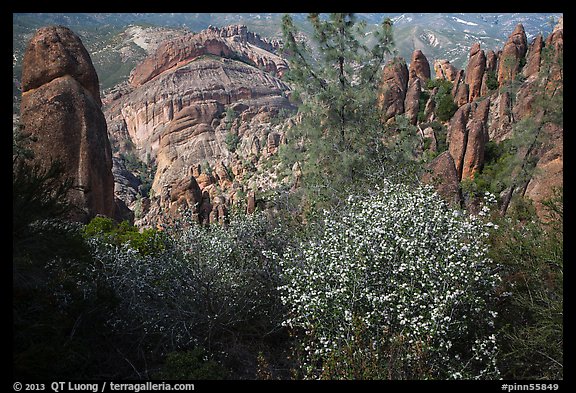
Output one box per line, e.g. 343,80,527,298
89,211,287,372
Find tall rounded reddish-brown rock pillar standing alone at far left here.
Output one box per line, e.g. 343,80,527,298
21,27,114,222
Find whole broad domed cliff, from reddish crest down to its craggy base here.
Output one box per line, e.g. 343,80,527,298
105,26,293,227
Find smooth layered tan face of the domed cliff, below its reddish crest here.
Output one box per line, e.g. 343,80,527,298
106,54,292,193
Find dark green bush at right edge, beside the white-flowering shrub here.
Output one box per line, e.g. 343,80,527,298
489,191,564,379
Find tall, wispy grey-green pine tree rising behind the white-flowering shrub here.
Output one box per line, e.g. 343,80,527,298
282,13,394,210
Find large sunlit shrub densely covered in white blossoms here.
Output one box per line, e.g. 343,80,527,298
273,183,499,379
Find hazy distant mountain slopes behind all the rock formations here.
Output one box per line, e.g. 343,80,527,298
12,13,561,99
